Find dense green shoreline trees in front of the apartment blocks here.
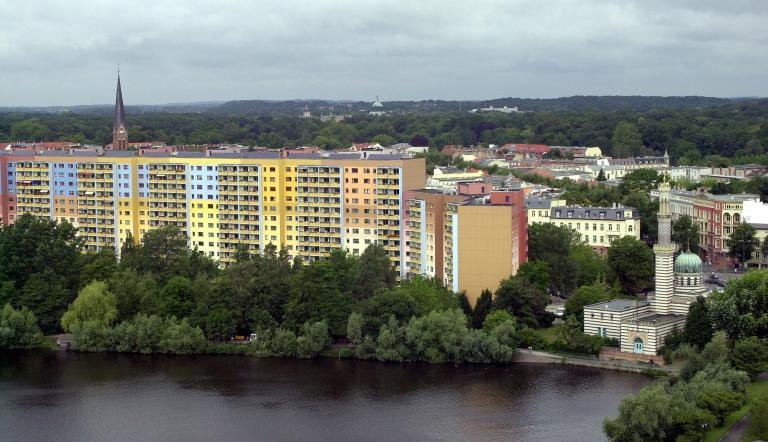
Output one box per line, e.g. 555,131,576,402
0,215,564,362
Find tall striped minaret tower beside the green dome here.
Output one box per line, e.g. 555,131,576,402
652,174,675,314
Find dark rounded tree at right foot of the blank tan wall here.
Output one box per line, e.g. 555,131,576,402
493,276,551,327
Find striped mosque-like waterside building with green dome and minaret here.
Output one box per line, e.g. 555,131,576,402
584,175,707,362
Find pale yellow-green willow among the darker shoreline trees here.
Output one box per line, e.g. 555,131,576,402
61,281,117,332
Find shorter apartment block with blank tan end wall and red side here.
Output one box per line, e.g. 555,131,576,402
405,189,528,304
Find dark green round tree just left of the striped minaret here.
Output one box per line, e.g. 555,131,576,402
608,236,654,294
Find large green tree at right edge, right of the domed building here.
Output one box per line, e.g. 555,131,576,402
708,270,768,341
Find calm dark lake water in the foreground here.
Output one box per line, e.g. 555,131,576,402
0,352,648,441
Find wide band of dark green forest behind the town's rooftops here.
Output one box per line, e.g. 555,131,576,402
0,100,768,163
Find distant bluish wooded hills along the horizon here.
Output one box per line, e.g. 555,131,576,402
0,95,766,116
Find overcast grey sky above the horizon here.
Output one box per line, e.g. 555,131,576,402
0,0,768,106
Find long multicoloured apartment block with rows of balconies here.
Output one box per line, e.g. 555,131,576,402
0,150,425,275
